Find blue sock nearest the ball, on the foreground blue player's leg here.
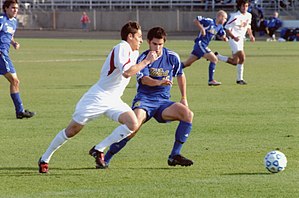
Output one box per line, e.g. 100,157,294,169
170,121,192,156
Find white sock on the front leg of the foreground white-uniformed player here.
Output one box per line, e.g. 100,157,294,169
95,124,133,152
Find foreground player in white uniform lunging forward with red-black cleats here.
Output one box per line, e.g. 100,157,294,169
38,22,157,173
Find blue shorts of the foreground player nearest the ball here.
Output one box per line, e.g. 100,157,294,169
132,95,175,123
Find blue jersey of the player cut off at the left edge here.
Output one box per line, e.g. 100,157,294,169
0,14,17,55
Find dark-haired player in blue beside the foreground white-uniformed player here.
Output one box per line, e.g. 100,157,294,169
93,27,193,168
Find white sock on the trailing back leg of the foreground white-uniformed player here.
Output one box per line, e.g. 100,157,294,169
41,129,69,163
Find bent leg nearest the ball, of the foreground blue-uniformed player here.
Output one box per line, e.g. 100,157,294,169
156,103,193,166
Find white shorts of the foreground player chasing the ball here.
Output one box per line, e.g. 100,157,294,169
73,84,132,125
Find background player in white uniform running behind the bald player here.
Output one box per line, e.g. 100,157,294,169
215,0,255,85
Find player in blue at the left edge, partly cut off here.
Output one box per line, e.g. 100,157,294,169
0,0,35,119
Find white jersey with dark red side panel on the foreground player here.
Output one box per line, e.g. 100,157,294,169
97,41,139,97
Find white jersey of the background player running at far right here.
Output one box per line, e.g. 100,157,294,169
225,11,252,38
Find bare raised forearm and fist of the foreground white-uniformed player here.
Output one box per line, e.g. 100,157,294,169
122,51,158,78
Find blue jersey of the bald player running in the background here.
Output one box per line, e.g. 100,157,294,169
195,16,225,47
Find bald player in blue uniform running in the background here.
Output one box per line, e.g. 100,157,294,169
183,10,227,86
